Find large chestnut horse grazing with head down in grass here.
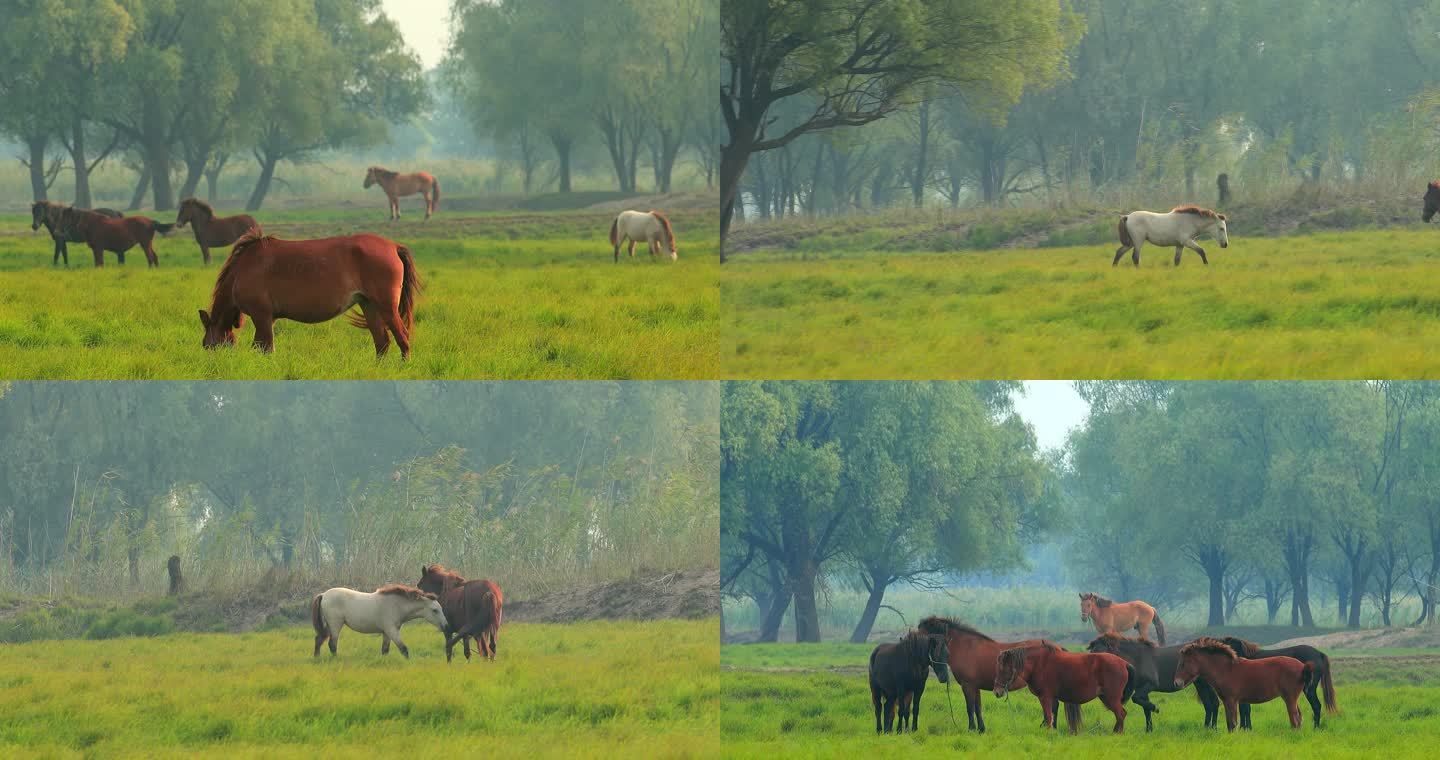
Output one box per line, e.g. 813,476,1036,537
200,229,420,357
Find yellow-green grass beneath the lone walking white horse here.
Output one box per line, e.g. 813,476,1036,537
721,230,1440,380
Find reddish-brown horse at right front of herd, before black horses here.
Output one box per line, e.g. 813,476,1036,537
1175,636,1312,731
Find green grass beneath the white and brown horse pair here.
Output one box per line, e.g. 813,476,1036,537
0,619,720,757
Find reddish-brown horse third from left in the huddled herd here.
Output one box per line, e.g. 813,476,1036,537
995,645,1135,734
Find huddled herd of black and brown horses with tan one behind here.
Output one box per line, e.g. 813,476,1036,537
870,593,1338,734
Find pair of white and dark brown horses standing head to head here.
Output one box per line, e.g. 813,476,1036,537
310,564,504,662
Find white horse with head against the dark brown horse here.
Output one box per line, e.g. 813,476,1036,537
310,583,445,658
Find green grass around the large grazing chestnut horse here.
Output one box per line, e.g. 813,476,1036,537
0,199,720,380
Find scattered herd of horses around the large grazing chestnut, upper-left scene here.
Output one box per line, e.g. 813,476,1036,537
18,167,680,358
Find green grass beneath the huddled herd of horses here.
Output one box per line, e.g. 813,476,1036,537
720,643,1440,759
